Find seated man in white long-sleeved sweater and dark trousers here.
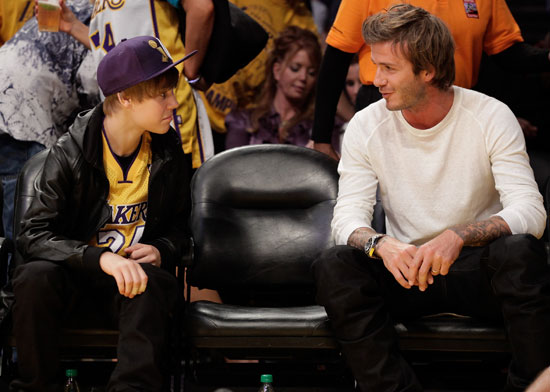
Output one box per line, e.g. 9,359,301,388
313,4,550,392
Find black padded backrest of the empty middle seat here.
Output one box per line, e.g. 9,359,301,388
189,145,338,305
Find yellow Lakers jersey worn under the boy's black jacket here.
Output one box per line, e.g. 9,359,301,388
90,130,152,256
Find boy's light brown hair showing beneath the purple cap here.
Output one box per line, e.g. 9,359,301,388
103,68,179,115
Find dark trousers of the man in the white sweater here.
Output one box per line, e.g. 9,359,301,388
313,235,550,392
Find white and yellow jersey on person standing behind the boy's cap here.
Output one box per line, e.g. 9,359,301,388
90,0,212,167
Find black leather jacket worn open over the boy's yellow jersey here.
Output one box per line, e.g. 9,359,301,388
17,105,191,270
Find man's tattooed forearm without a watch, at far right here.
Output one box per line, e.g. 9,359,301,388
449,216,512,246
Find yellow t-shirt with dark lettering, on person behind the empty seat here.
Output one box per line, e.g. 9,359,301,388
203,0,317,132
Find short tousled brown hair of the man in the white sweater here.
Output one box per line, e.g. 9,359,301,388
363,4,455,90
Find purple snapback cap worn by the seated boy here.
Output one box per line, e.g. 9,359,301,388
97,35,197,96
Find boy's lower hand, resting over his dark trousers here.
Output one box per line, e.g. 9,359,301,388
99,252,148,298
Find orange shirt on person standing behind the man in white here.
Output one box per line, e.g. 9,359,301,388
327,0,523,88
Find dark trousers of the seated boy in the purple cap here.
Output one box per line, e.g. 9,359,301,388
10,261,178,392
